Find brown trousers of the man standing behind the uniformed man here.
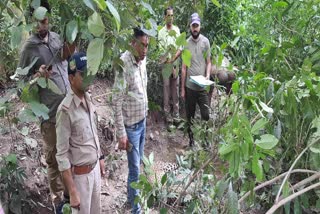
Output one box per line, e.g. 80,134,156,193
41,122,64,199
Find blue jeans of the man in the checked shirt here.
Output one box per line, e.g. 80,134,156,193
125,119,146,214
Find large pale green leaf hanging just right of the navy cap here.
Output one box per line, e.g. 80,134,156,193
87,38,104,75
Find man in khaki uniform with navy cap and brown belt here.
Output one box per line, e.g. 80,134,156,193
56,53,105,214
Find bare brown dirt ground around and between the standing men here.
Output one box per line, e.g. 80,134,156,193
0,79,188,214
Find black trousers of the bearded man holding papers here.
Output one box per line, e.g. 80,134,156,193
185,88,209,140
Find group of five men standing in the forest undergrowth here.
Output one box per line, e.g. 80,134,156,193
19,1,218,214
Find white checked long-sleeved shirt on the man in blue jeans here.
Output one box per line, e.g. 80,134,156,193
112,51,148,138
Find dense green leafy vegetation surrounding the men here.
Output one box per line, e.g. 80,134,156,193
0,0,320,213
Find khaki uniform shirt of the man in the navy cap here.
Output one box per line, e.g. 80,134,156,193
56,90,101,171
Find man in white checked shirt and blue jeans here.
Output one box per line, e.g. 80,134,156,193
113,28,149,213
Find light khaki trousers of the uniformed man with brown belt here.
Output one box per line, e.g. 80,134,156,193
72,161,101,214
